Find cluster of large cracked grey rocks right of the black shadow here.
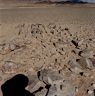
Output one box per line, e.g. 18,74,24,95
29,69,75,96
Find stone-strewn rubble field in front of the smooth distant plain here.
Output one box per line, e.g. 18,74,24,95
0,23,95,96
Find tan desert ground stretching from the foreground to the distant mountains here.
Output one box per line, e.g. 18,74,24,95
0,6,95,96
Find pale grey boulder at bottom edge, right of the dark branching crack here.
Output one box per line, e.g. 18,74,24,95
47,82,75,96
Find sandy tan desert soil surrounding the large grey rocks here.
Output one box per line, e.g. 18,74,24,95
0,6,95,96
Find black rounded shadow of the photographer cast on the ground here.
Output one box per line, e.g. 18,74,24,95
1,74,34,96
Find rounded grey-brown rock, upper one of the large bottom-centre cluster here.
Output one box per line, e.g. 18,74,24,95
39,69,64,85
